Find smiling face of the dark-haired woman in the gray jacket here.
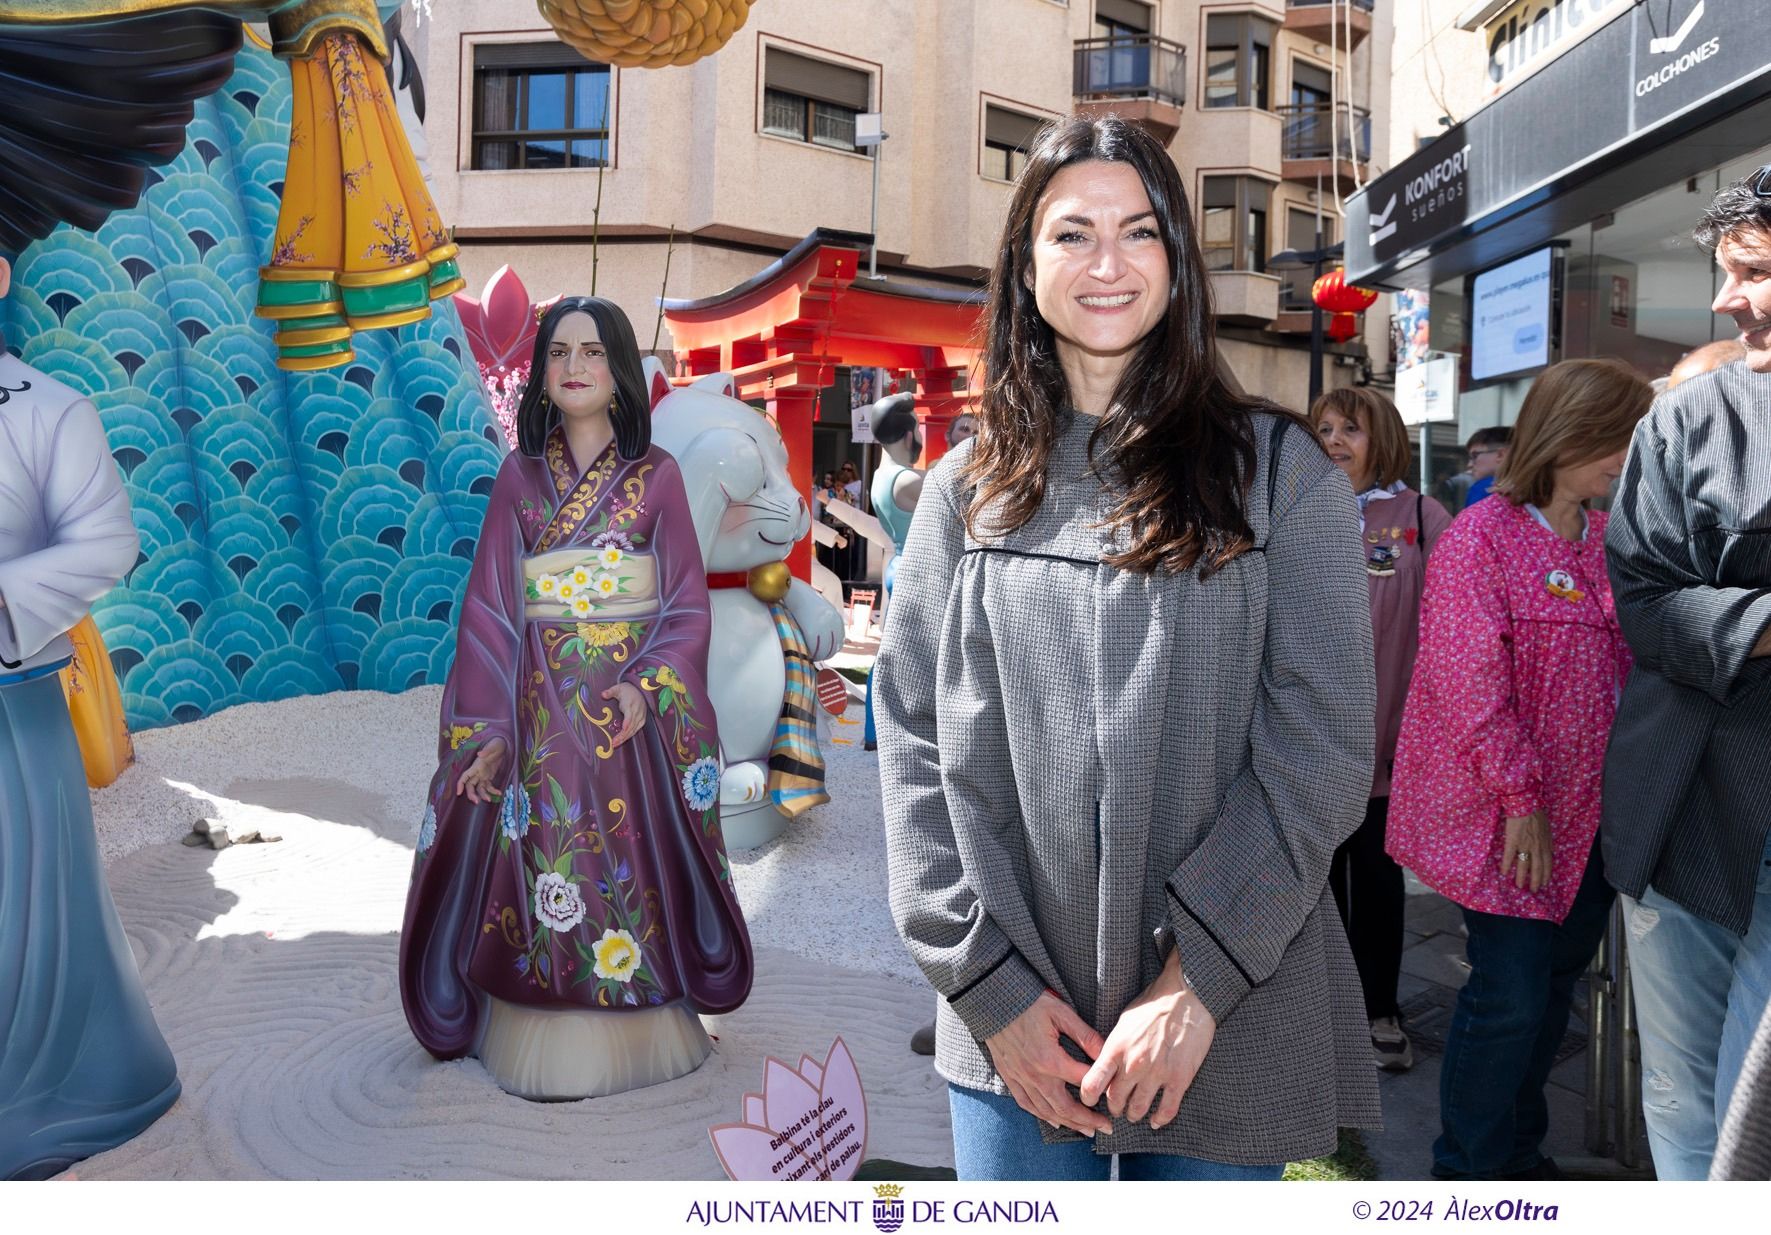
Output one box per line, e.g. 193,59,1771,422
1027,159,1171,377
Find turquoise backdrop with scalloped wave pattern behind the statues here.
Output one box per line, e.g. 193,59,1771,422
0,31,503,728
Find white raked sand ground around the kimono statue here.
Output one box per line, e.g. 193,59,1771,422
76,687,953,1178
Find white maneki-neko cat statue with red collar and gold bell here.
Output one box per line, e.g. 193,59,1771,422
645,356,843,849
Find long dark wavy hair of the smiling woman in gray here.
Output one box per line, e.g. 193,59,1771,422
963,115,1291,578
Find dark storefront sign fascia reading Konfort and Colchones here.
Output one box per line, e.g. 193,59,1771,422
1346,0,1771,289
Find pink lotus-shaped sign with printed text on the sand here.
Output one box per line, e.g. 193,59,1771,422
710,1038,868,1184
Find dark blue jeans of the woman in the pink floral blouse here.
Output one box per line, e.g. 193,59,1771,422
1433,845,1613,1178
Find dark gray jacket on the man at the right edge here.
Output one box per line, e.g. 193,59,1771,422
1599,363,1771,936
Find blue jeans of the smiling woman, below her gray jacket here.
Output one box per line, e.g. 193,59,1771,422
947,1084,1286,1184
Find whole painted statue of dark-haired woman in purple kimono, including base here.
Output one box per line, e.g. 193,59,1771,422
400,296,751,1100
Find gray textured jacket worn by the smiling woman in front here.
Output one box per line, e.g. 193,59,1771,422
873,415,1378,1164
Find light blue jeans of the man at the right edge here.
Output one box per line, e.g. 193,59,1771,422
1624,829,1771,1180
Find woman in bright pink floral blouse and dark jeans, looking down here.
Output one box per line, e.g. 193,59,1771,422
1387,360,1652,1178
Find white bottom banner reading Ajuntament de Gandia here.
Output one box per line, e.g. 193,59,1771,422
5,1180,1771,1235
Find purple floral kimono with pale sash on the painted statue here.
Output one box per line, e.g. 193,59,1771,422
400,431,751,1060
